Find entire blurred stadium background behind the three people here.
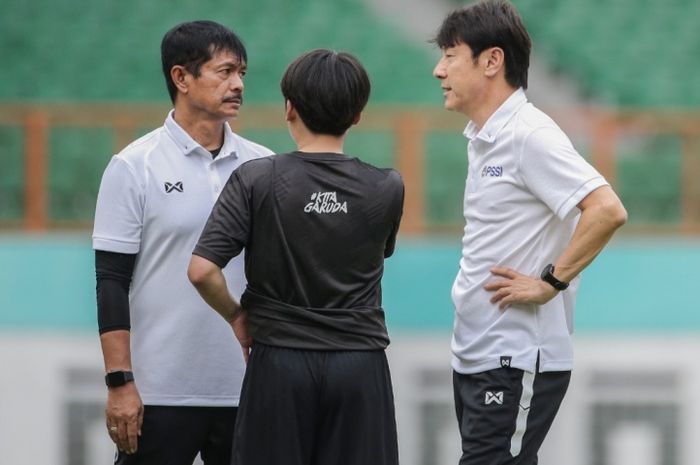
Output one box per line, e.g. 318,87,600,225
0,0,700,465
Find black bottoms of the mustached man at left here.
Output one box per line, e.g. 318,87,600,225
114,405,238,465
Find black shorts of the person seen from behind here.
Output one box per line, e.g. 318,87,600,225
233,344,398,465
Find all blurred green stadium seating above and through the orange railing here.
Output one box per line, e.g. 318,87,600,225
0,0,700,225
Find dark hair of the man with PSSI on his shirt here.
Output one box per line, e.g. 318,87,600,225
433,0,532,89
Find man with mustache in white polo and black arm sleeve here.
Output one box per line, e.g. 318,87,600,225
93,21,271,465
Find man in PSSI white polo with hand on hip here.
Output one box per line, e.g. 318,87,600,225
433,0,627,465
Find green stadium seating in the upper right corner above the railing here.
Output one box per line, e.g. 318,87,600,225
516,0,700,108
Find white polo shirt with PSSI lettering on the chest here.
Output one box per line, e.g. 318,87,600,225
452,89,607,374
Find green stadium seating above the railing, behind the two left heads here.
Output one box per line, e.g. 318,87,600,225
0,0,439,103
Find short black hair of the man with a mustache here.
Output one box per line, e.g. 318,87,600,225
160,21,248,103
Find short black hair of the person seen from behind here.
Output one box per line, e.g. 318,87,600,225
280,49,371,136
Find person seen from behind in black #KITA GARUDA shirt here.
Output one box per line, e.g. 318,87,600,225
188,50,403,465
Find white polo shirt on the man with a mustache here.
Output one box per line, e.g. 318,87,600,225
92,111,272,406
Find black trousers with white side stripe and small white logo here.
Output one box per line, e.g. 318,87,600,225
453,367,571,465
